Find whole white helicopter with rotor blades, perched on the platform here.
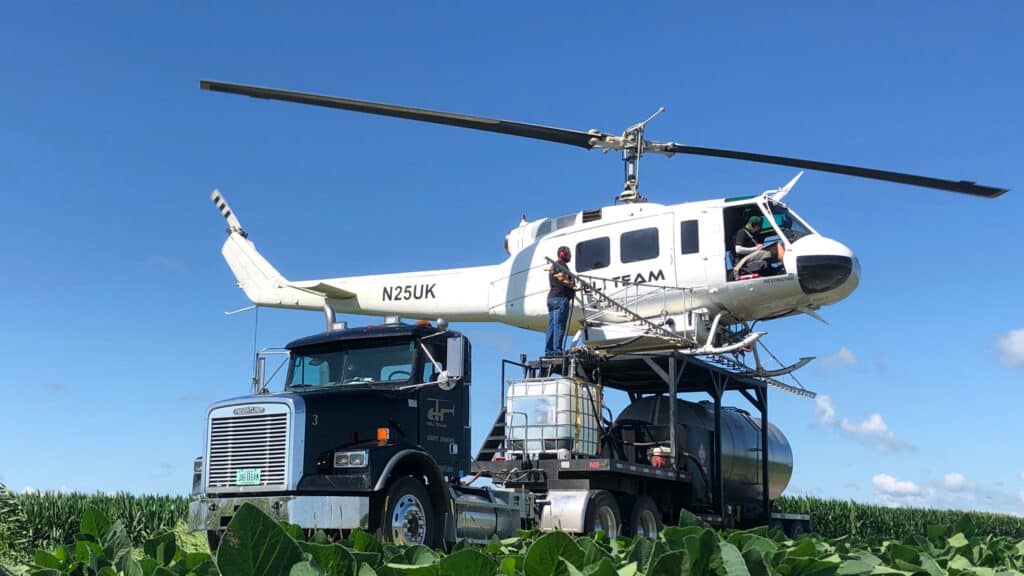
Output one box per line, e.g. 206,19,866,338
200,81,1007,366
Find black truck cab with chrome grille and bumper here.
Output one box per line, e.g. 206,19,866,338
189,322,499,546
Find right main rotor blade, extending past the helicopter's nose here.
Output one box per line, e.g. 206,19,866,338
664,143,1008,198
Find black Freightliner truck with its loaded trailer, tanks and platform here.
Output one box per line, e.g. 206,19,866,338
189,313,810,547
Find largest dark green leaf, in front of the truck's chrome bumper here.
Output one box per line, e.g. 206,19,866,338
217,503,302,576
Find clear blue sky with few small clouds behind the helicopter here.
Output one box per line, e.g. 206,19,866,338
0,1,1024,515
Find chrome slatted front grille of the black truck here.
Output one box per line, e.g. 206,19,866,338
206,413,289,492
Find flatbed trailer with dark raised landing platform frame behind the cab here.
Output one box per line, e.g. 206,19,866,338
473,349,812,534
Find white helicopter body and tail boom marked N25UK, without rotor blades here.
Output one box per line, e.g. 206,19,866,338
223,193,860,330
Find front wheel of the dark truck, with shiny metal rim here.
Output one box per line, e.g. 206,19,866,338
381,476,437,546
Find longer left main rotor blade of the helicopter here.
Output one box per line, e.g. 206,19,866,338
199,80,602,150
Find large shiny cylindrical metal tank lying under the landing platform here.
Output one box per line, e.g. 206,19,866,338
616,397,793,503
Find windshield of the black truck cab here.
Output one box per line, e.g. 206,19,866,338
288,342,416,388
